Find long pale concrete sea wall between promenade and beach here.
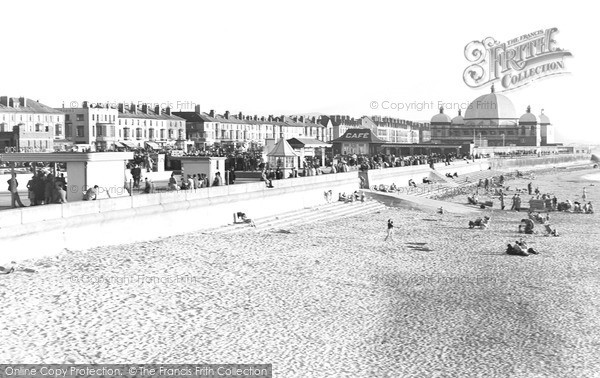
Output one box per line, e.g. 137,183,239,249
0,172,359,262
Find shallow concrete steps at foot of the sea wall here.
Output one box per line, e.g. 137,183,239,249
203,201,385,235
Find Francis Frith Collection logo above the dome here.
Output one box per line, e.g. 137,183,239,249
463,28,571,90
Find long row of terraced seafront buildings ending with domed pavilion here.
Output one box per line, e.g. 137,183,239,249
0,88,555,153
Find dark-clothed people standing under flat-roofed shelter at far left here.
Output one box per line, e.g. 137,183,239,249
6,169,67,208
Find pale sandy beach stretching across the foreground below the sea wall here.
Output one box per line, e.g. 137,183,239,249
0,170,600,377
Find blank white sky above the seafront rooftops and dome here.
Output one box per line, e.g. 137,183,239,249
0,0,600,144
